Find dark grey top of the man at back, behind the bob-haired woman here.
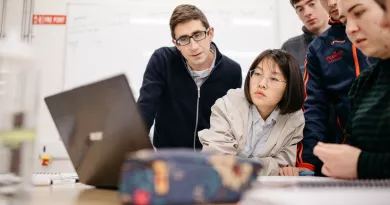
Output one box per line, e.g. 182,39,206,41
282,26,315,74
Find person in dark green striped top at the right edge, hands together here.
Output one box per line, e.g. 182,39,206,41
314,0,390,179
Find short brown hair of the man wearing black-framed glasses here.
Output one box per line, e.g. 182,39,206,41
169,4,210,39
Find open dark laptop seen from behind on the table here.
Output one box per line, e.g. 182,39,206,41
45,74,154,189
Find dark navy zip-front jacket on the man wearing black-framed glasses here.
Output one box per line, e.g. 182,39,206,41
137,43,242,149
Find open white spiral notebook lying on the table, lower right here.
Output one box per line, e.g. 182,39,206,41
240,176,390,205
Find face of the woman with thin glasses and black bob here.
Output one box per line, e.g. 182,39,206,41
249,59,287,109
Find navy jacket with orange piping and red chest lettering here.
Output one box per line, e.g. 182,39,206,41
297,19,369,174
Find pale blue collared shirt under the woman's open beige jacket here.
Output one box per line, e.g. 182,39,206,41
238,105,280,158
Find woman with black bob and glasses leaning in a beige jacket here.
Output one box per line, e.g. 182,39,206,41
199,49,305,175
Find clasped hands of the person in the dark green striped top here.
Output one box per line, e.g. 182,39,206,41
313,142,361,179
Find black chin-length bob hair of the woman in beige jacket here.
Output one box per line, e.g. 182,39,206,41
244,49,305,115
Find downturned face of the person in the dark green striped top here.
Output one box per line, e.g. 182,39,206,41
338,0,390,58
